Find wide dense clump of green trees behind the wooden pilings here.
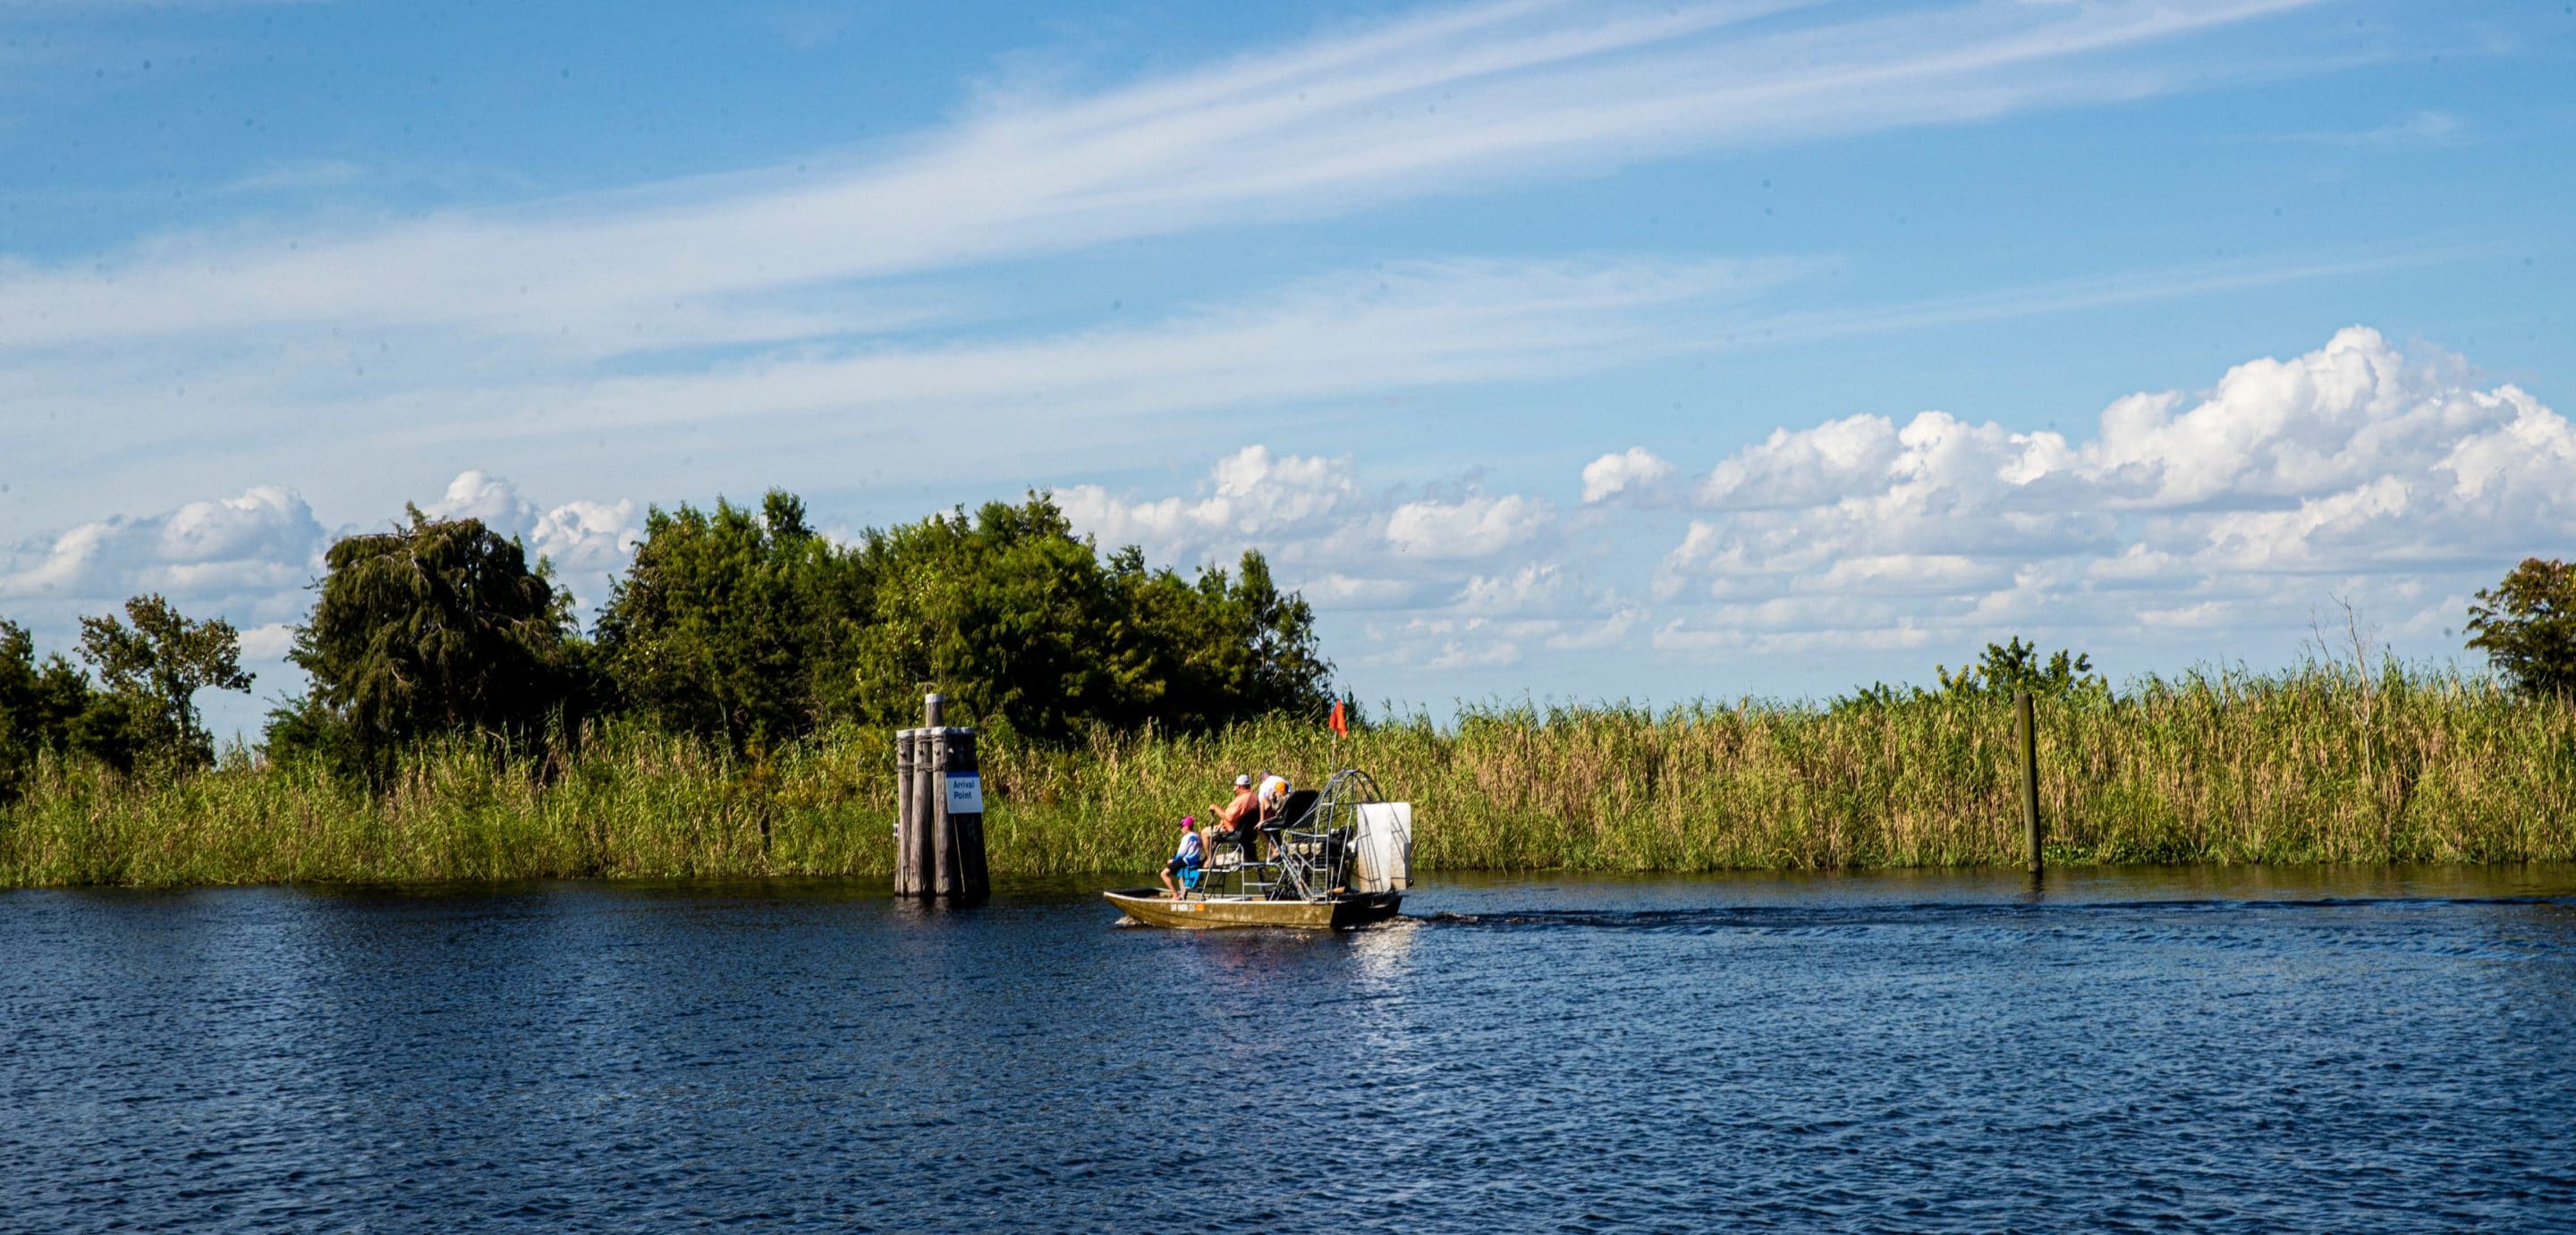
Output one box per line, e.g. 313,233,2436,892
597,492,1332,749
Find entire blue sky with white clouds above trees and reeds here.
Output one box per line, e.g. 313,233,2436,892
0,0,2576,725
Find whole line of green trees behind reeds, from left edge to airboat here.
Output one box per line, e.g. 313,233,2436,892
0,492,1332,798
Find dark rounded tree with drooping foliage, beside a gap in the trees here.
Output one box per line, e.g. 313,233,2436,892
268,507,582,766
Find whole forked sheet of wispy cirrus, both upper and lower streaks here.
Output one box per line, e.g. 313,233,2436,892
0,0,2369,540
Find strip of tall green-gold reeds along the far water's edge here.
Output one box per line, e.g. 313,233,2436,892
0,669,2576,885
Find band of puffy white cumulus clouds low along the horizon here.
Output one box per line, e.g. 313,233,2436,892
0,326,2576,710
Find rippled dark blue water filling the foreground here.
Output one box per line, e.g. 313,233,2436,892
0,867,2576,1230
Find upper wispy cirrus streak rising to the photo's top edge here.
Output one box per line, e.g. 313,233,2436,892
0,0,2310,355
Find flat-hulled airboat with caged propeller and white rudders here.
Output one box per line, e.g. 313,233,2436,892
1100,766,1414,932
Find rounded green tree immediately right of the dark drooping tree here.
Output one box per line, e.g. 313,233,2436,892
597,492,870,749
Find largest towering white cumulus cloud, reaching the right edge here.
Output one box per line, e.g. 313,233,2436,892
1648,326,2576,651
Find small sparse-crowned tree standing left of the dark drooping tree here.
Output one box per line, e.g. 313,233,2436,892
80,595,250,769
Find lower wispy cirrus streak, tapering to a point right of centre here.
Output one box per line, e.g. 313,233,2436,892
0,260,1811,512
